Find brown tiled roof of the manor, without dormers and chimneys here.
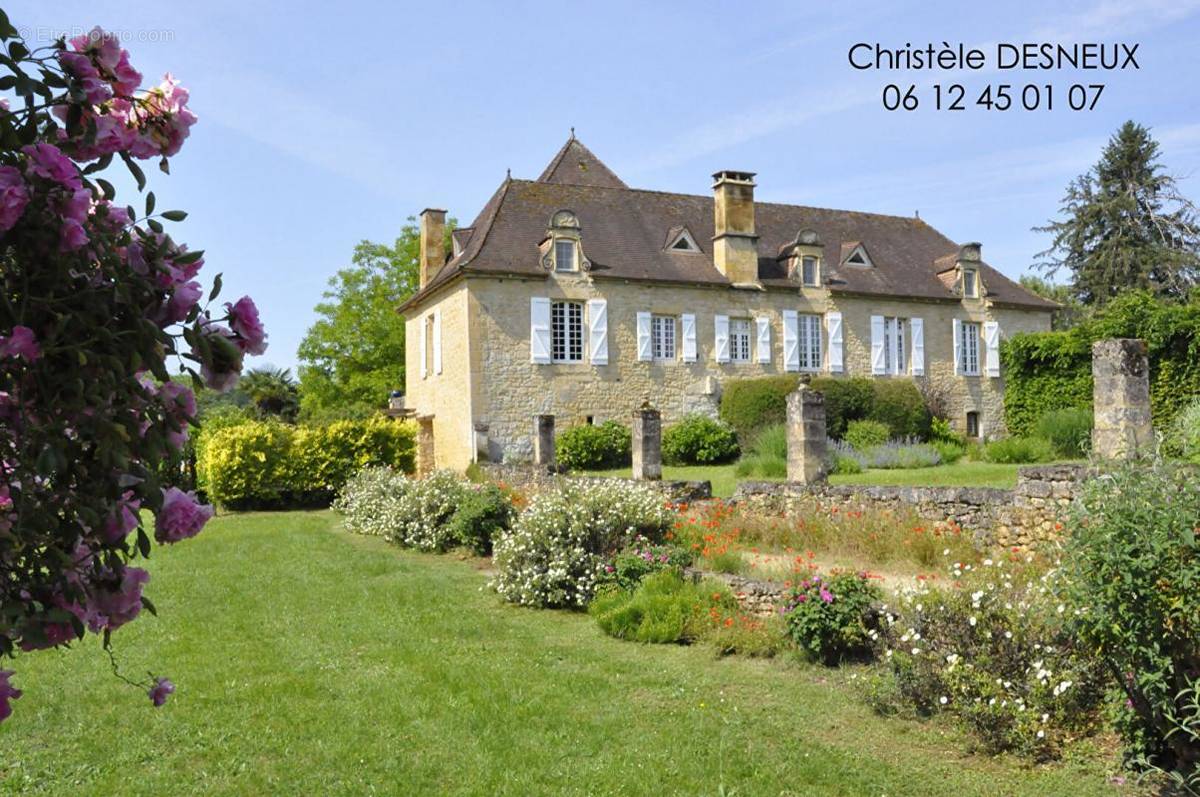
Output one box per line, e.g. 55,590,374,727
401,134,1057,311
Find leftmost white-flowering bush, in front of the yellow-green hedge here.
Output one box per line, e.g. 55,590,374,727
334,467,468,551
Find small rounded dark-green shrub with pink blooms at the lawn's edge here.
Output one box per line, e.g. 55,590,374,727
779,573,882,665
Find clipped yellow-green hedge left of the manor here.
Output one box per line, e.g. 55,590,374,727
196,418,416,509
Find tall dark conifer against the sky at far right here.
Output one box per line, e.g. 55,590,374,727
1034,121,1200,305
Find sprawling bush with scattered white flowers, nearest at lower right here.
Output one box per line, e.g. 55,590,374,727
870,559,1106,760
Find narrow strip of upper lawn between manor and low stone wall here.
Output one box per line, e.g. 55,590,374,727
590,460,1021,498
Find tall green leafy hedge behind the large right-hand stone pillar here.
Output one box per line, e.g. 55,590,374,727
1001,292,1200,435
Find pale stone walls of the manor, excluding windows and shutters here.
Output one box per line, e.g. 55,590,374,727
406,272,1050,469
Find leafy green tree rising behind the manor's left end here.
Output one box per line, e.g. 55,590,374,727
299,216,455,418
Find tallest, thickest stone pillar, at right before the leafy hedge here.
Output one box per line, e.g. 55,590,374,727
1092,337,1154,460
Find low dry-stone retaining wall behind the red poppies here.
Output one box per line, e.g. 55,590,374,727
733,465,1087,547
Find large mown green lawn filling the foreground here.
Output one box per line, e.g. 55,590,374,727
0,513,1115,797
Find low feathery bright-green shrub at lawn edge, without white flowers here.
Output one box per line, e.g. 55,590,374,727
588,568,738,643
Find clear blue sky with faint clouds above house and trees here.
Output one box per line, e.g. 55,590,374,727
5,0,1200,367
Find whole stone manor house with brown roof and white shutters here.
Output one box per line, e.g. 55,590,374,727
400,134,1056,469
